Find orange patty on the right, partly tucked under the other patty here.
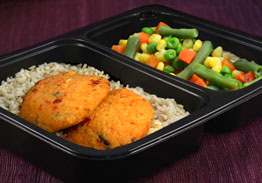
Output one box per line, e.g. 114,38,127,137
65,89,154,149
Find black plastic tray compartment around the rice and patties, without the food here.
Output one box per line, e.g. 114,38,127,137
0,39,208,181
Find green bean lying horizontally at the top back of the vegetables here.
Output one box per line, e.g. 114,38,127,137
158,26,198,39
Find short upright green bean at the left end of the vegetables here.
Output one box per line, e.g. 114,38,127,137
124,35,140,58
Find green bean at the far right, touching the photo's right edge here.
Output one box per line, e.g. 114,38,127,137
233,58,262,72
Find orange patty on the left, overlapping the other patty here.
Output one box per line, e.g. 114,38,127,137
19,71,110,132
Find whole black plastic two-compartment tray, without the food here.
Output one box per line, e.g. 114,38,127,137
0,5,262,182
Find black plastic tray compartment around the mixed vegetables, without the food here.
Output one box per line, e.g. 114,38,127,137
82,5,262,132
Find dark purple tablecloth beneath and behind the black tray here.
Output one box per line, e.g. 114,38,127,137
0,0,262,183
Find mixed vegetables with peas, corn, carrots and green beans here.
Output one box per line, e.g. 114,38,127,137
112,22,262,90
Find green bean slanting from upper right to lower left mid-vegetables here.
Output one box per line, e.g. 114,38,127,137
177,41,213,79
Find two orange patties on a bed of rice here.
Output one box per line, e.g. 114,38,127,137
0,63,189,150
